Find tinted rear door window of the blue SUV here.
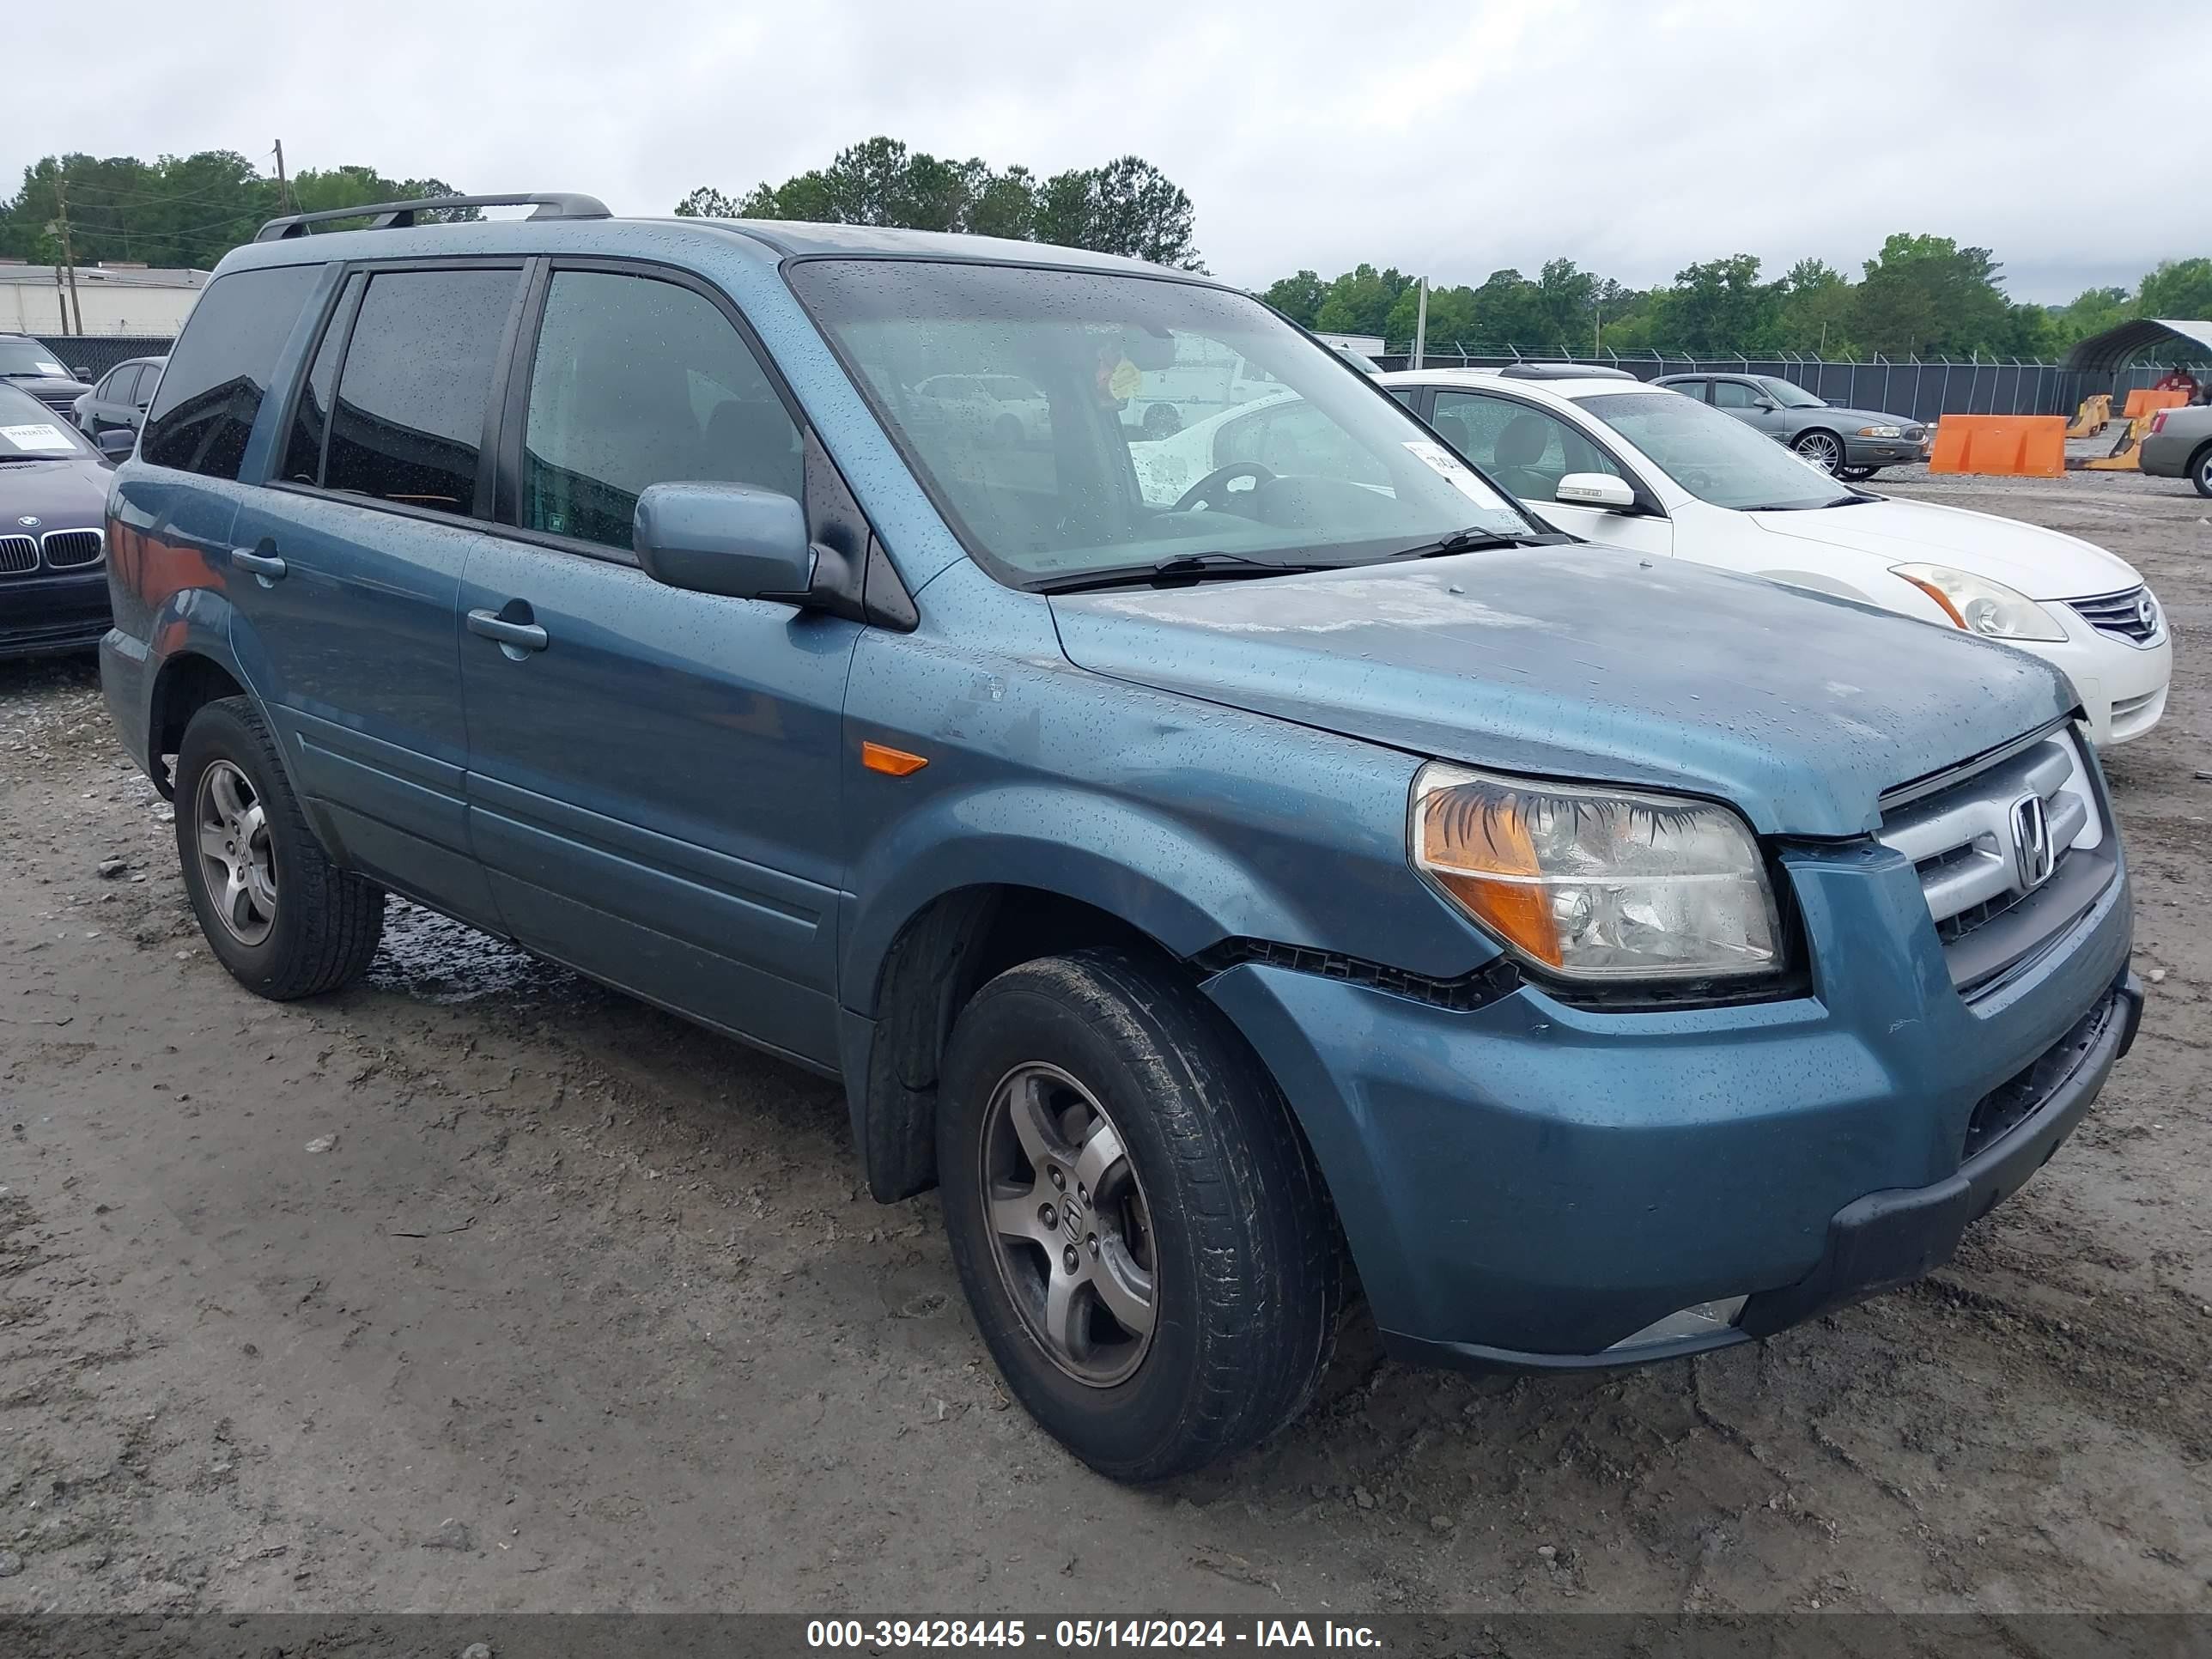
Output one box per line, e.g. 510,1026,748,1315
320,270,520,514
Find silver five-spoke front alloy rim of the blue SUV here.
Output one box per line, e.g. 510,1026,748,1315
978,1061,1159,1389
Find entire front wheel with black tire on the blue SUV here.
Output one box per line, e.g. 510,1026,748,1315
938,949,1343,1482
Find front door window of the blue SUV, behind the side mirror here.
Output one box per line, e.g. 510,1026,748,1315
517,270,805,550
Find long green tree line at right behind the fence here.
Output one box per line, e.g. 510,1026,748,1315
1261,232,2212,358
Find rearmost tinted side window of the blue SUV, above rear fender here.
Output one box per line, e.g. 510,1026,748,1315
139,265,323,477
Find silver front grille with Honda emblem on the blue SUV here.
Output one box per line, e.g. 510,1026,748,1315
1881,732,2117,988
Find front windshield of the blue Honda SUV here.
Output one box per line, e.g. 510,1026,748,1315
792,258,1541,586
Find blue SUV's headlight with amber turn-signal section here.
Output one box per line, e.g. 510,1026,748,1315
1411,761,1781,980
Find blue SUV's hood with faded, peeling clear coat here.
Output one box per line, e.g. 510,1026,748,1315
1051,546,2075,836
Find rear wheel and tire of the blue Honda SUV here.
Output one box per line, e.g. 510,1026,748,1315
177,696,385,1002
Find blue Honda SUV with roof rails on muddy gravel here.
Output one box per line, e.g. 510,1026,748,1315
101,197,2142,1480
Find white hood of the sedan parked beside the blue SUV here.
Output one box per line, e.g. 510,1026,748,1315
1743,498,2143,599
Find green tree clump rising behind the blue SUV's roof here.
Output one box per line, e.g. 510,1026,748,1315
677,137,1206,270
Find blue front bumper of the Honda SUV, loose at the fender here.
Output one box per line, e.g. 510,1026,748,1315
1206,845,2135,1367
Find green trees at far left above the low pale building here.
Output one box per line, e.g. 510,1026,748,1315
0,150,476,270
